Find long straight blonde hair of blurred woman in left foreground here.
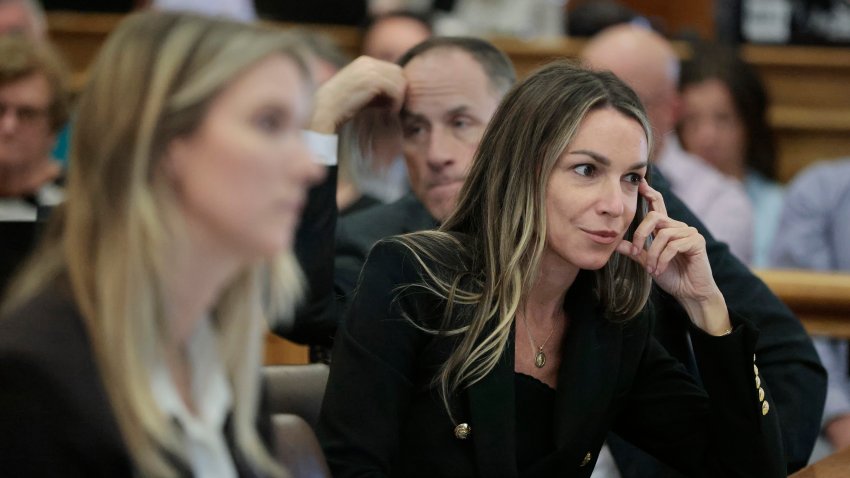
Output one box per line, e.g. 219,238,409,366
4,12,308,476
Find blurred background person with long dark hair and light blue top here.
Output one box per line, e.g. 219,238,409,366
678,44,783,267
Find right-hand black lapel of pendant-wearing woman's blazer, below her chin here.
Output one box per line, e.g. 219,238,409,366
555,271,622,452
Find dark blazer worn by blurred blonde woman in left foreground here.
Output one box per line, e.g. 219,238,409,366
0,284,270,478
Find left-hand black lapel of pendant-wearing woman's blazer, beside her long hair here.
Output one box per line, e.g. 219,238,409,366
467,331,517,477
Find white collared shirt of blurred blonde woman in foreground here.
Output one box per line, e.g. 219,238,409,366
151,317,237,478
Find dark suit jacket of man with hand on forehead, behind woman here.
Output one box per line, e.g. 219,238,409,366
291,169,826,478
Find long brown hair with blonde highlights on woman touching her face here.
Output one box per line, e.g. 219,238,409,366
397,61,652,416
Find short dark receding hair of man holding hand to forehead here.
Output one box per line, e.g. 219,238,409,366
398,37,516,95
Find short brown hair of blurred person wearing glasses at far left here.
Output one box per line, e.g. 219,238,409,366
0,35,69,132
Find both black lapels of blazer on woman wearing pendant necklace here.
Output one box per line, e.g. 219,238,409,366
466,272,622,477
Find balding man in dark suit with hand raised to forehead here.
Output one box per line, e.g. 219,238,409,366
286,37,826,476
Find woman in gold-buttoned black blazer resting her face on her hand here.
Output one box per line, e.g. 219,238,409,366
319,63,786,477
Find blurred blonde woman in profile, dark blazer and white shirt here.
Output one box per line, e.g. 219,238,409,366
0,13,323,477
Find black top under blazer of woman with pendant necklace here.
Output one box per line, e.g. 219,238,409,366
514,372,555,474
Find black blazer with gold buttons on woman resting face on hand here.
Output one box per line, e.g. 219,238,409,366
319,241,785,478
